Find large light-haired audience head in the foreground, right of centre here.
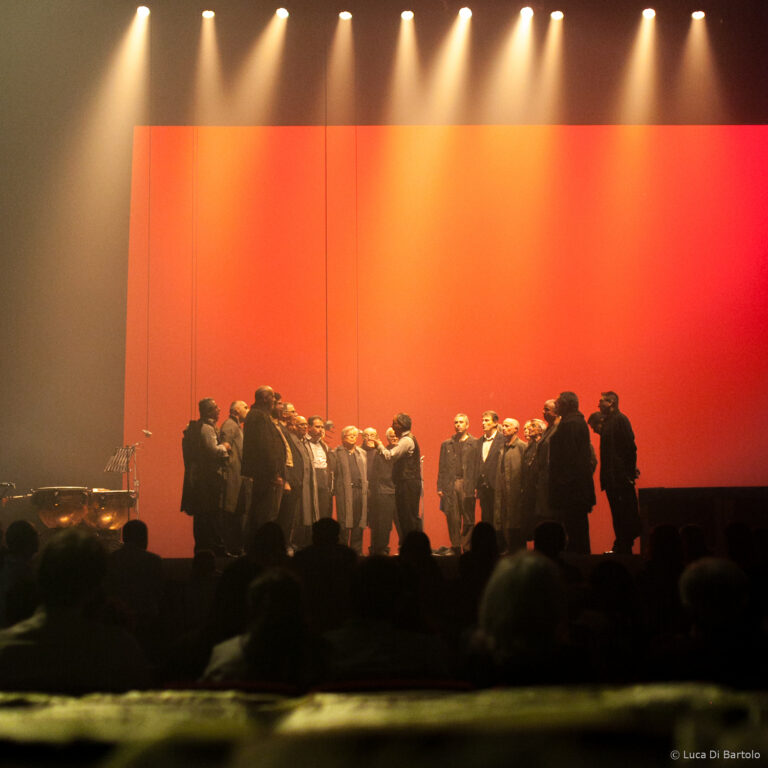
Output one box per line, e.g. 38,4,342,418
480,551,565,663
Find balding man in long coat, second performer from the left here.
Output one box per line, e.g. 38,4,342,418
219,400,251,554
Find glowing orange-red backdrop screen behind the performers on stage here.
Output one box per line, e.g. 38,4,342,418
125,126,768,556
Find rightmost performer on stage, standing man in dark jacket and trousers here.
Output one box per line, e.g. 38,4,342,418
599,391,640,554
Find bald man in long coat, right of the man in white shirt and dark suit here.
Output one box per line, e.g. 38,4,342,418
493,418,533,554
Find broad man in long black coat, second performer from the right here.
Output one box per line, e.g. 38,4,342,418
549,392,595,554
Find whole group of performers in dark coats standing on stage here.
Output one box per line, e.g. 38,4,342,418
181,386,640,556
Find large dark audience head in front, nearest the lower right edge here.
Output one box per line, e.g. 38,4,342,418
680,557,749,635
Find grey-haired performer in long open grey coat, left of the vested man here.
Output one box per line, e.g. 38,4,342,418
333,426,368,555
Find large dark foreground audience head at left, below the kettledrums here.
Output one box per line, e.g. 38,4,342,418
38,528,107,609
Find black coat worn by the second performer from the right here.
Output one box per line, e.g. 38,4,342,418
549,411,595,510
